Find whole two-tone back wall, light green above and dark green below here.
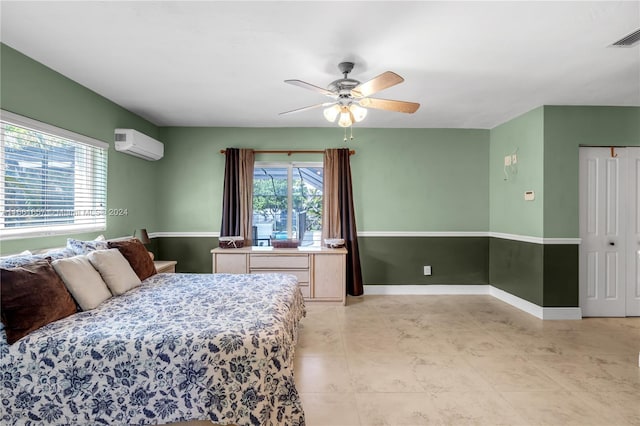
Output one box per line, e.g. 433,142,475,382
158,127,489,284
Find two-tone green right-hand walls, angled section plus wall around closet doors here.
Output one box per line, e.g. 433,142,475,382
489,106,640,307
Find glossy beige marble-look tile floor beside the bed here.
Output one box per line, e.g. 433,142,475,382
295,296,640,426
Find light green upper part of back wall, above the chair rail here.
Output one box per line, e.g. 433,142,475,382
158,127,489,232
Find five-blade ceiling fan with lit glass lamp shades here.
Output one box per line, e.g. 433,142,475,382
280,62,420,127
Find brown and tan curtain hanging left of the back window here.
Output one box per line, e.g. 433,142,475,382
220,148,254,246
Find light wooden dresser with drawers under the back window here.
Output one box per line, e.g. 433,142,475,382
211,247,347,305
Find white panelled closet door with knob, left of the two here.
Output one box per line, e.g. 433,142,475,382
579,148,628,317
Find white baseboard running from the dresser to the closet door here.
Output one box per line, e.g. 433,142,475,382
364,284,582,320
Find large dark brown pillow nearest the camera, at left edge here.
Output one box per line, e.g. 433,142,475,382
0,258,77,344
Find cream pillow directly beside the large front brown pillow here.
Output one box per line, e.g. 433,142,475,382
51,256,111,311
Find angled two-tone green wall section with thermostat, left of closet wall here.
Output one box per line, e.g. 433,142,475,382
489,107,545,306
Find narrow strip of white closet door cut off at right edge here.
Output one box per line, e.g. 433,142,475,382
626,148,640,317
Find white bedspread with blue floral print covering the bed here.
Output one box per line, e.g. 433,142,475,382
0,274,304,425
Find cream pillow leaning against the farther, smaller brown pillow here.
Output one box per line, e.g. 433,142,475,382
87,249,142,296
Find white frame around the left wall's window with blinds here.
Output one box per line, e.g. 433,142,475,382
0,110,109,241
